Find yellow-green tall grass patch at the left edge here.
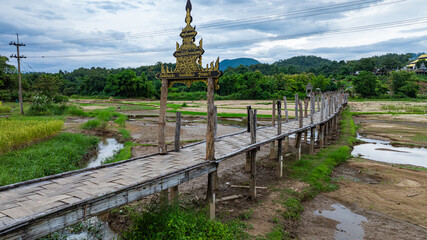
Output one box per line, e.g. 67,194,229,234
0,118,64,154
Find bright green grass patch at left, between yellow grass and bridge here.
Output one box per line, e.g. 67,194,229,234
0,133,98,186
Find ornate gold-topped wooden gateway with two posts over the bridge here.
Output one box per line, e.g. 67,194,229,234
156,0,222,161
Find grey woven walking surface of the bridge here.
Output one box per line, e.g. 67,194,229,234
0,109,338,236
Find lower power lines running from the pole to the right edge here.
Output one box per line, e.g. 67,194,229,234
29,17,427,58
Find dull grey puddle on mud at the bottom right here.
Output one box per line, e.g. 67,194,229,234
313,203,367,240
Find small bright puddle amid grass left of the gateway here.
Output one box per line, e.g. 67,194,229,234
87,138,124,168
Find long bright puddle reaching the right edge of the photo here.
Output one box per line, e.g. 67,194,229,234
351,135,427,168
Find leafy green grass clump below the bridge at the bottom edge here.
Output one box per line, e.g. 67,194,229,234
117,203,247,240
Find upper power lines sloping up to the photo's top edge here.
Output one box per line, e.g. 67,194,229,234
25,0,407,45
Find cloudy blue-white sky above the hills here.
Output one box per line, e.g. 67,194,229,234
0,0,427,72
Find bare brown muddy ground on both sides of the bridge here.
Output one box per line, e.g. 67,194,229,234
67,101,427,239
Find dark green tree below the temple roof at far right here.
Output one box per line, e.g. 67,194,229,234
391,71,419,98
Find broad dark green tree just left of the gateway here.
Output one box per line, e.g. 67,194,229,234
104,70,153,97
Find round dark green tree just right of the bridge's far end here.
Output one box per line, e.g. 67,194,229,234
353,71,380,97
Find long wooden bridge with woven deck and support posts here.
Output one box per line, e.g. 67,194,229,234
0,94,347,239
